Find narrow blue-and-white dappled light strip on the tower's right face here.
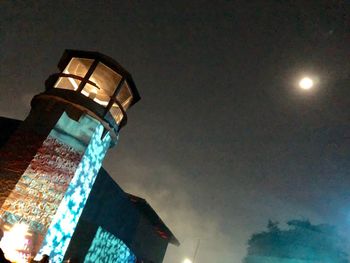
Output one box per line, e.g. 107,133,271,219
37,125,111,263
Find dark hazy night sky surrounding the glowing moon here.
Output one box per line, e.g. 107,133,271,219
0,0,350,263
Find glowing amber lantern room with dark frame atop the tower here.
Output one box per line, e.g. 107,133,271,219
45,50,140,134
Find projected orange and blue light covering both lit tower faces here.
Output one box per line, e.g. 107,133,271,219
0,113,111,262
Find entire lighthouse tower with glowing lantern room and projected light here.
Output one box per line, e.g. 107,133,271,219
0,50,140,262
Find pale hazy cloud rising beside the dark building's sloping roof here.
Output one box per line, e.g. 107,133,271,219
109,160,245,263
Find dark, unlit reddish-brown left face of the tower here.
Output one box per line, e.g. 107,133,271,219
0,101,64,209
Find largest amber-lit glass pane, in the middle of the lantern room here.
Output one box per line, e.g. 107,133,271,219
82,63,122,106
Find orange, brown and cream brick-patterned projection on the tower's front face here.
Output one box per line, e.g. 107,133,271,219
0,136,82,234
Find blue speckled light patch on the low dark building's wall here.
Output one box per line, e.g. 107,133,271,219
84,227,136,263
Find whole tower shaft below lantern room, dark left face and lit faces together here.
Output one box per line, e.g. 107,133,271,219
0,97,111,262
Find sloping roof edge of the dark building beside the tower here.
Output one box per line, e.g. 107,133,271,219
126,193,180,246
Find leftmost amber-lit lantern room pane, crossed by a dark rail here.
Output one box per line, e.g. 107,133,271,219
54,58,93,90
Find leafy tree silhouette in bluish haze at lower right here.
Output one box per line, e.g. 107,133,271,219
243,220,349,263
